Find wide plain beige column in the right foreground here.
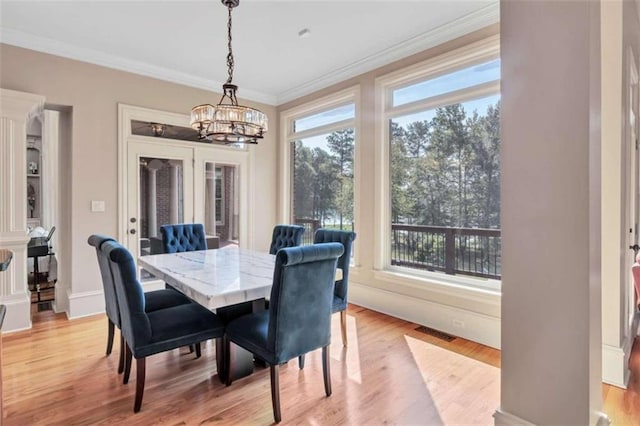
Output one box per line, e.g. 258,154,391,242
495,0,602,425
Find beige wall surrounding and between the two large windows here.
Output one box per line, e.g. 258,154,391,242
278,24,500,347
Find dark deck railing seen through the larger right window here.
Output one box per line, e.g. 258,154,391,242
391,223,502,279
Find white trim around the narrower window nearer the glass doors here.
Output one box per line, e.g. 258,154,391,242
278,85,362,265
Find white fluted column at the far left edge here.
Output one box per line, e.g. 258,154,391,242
0,89,45,331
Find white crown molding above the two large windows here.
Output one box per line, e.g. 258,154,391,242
276,0,500,105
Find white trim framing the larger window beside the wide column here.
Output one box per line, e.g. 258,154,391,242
373,35,501,291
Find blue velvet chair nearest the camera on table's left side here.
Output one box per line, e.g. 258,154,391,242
102,241,224,413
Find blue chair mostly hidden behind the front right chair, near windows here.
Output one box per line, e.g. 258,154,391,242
313,228,356,346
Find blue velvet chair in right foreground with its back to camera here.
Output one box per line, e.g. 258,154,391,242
225,243,344,423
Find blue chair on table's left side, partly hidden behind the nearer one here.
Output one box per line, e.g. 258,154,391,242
88,234,192,373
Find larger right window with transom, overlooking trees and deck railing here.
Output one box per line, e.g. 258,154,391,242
383,46,501,279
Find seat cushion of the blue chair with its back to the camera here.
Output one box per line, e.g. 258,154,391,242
225,310,279,365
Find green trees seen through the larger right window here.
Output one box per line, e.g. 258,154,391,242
390,101,500,228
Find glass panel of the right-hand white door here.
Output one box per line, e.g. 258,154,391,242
204,162,240,247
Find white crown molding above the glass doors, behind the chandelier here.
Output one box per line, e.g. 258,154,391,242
0,27,277,105
